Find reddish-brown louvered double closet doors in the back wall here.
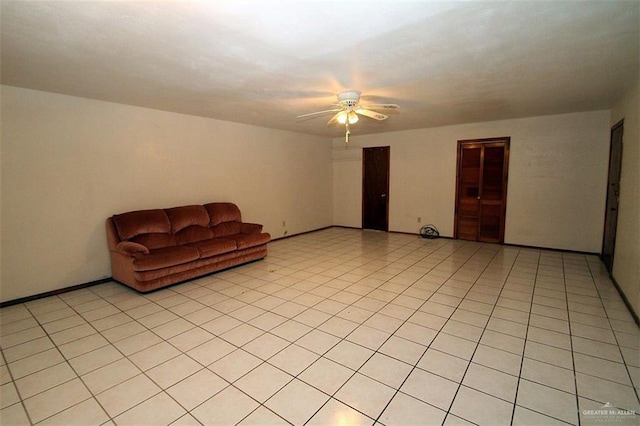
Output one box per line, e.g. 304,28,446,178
454,138,510,243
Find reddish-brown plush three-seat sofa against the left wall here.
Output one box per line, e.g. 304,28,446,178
107,203,271,292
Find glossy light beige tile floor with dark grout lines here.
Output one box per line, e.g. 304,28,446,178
0,228,640,425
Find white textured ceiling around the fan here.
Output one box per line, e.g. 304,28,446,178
0,0,640,137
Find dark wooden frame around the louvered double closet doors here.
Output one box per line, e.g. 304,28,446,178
453,136,511,244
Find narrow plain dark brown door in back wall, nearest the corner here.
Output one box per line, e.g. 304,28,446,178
362,146,390,231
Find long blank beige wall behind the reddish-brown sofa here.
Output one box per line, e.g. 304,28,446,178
0,86,333,301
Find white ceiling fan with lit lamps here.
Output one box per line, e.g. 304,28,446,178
298,90,400,126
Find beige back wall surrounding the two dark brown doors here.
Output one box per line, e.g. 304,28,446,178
333,111,610,253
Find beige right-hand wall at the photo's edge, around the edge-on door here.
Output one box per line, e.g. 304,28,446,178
610,81,640,315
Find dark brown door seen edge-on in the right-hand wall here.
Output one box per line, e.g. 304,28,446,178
600,121,624,272
